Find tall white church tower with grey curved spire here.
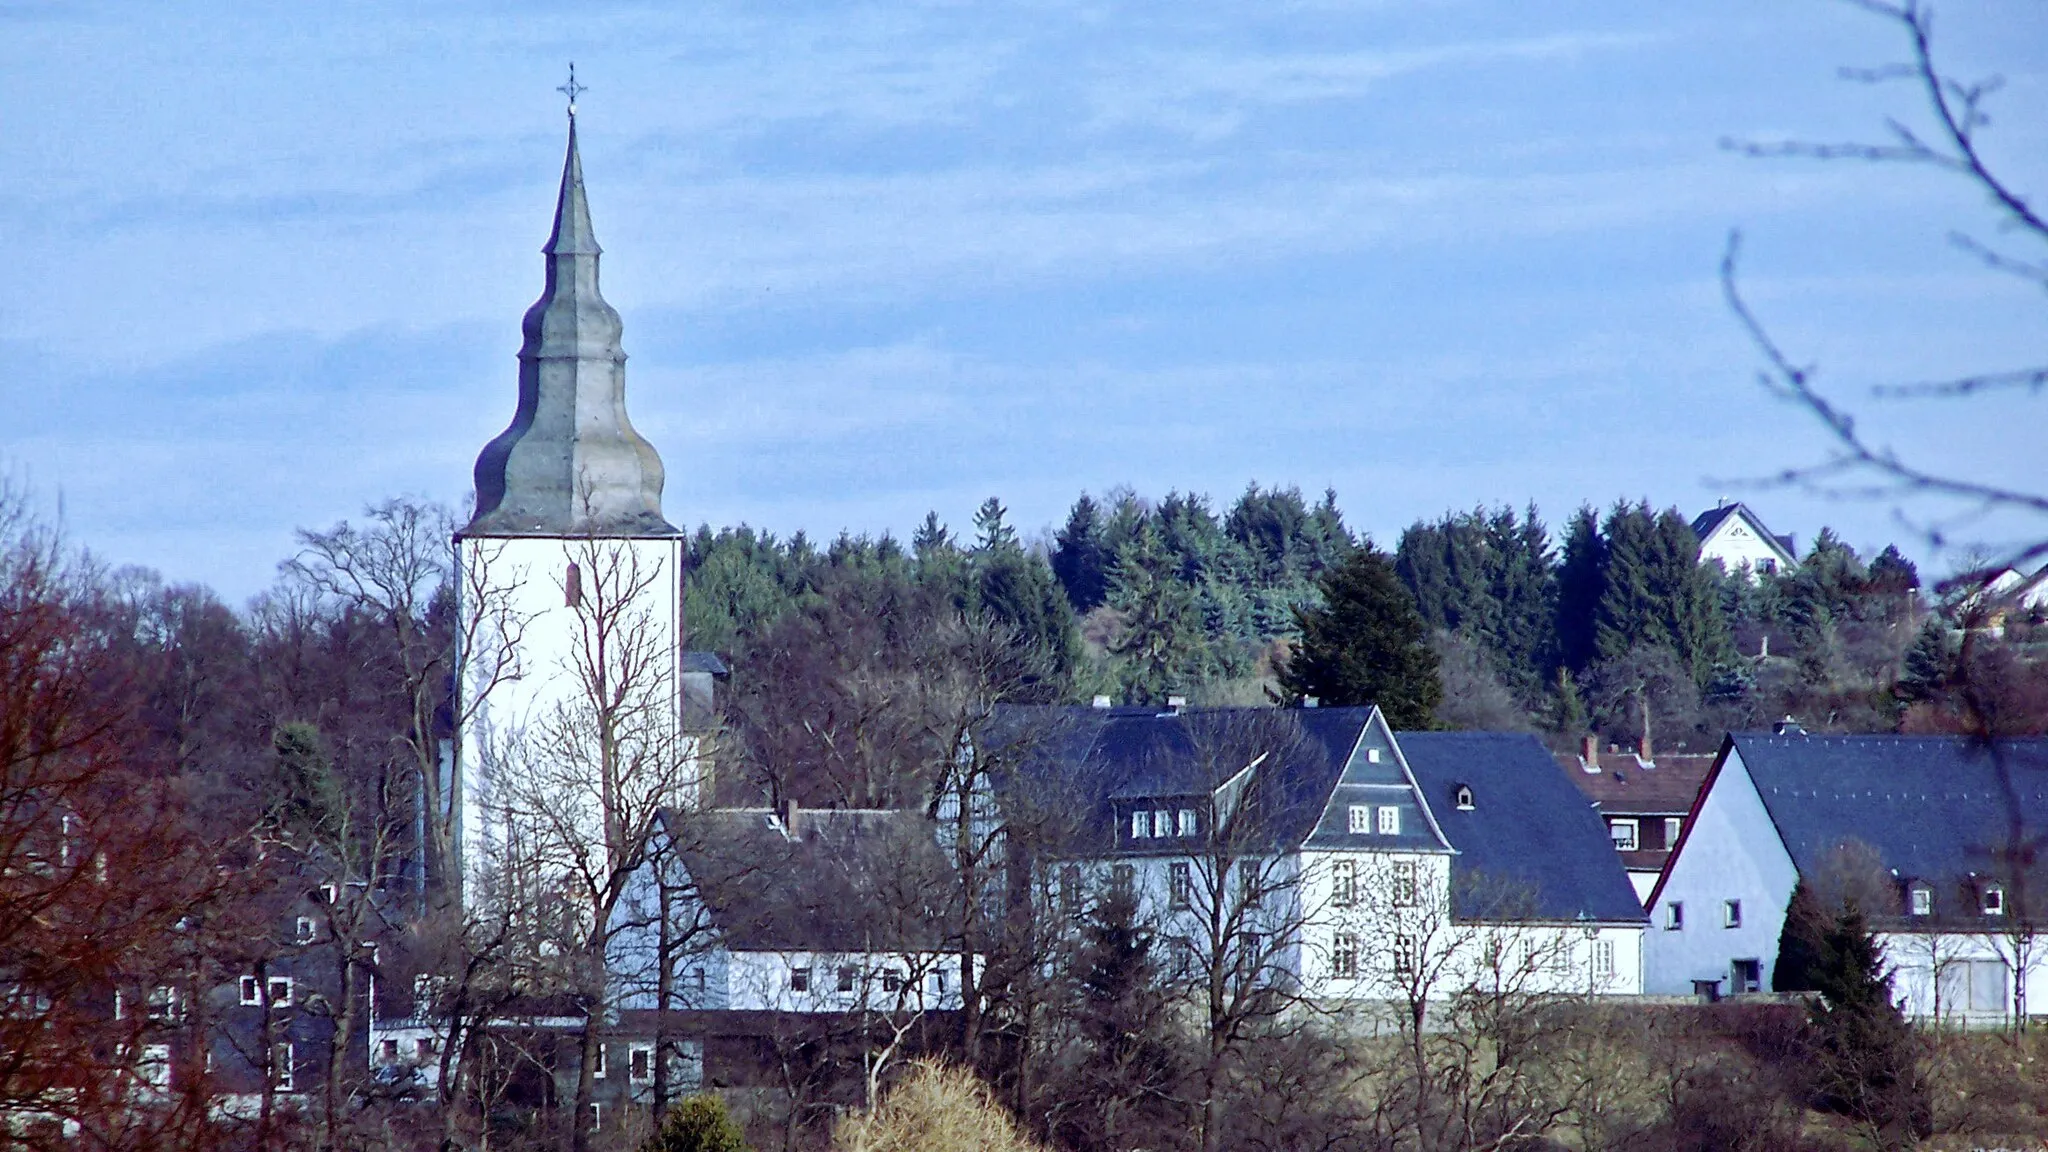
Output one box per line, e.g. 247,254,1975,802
444,103,696,900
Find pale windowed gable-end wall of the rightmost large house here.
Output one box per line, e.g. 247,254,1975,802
1642,748,1798,994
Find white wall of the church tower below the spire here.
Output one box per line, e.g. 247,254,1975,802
449,537,698,900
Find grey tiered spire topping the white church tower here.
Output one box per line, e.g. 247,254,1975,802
463,105,676,535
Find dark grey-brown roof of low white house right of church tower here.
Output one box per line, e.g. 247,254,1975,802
668,808,946,951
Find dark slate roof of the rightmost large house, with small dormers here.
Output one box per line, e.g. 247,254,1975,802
1722,734,2048,881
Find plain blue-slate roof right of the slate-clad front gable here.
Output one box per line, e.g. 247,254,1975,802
1395,732,1645,922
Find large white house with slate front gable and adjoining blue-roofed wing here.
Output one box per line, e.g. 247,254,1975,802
995,707,1642,1002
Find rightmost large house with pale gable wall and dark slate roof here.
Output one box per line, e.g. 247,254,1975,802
1647,726,2048,1023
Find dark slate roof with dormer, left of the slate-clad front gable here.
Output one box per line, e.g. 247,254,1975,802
995,707,1372,855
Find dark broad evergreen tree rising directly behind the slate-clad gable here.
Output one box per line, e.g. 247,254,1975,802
1280,545,1444,728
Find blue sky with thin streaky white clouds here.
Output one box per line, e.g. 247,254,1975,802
0,0,2048,599
